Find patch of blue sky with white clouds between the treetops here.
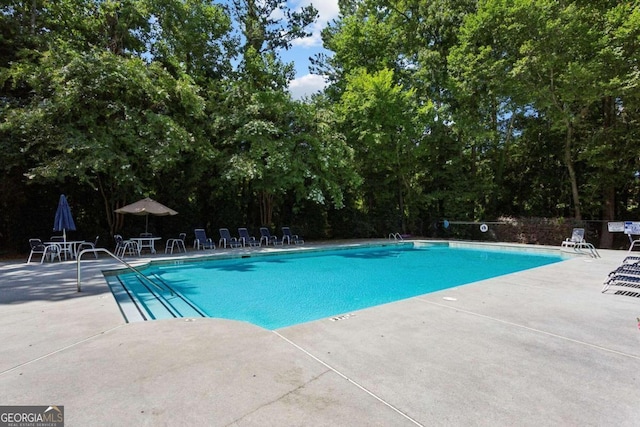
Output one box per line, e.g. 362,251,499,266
281,0,338,99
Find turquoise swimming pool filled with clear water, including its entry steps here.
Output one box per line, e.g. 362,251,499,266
107,243,563,329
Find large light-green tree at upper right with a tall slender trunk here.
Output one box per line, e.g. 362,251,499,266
451,0,630,226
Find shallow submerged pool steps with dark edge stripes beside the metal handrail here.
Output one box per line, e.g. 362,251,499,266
106,274,205,323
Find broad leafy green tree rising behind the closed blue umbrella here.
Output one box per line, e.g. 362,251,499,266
1,52,203,237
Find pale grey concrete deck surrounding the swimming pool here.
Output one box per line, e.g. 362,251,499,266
0,244,640,426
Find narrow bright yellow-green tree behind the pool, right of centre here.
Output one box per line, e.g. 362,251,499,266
339,69,432,233
